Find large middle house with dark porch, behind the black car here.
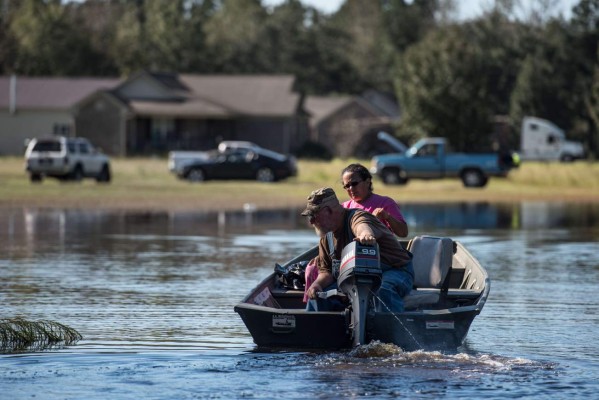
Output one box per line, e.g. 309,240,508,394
74,71,308,156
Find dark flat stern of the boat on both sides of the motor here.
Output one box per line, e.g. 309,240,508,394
235,304,479,351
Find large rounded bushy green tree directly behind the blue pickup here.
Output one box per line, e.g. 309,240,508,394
395,14,520,150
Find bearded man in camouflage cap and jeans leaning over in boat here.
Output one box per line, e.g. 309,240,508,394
302,187,414,312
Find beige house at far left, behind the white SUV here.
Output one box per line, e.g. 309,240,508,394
0,75,120,155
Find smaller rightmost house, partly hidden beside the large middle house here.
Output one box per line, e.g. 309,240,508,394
304,90,400,158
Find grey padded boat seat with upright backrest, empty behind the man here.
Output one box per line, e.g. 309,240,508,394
403,236,454,310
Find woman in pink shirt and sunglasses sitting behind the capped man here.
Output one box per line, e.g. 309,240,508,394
304,164,408,303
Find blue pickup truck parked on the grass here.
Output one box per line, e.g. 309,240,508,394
370,138,516,187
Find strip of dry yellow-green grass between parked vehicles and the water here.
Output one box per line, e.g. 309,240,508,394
0,157,599,210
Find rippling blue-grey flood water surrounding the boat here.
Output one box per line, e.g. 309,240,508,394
0,203,599,399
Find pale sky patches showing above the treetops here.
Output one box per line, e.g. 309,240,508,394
262,0,580,19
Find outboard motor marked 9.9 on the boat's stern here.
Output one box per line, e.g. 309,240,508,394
337,241,383,346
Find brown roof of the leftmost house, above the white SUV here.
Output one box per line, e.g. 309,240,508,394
0,76,120,110
